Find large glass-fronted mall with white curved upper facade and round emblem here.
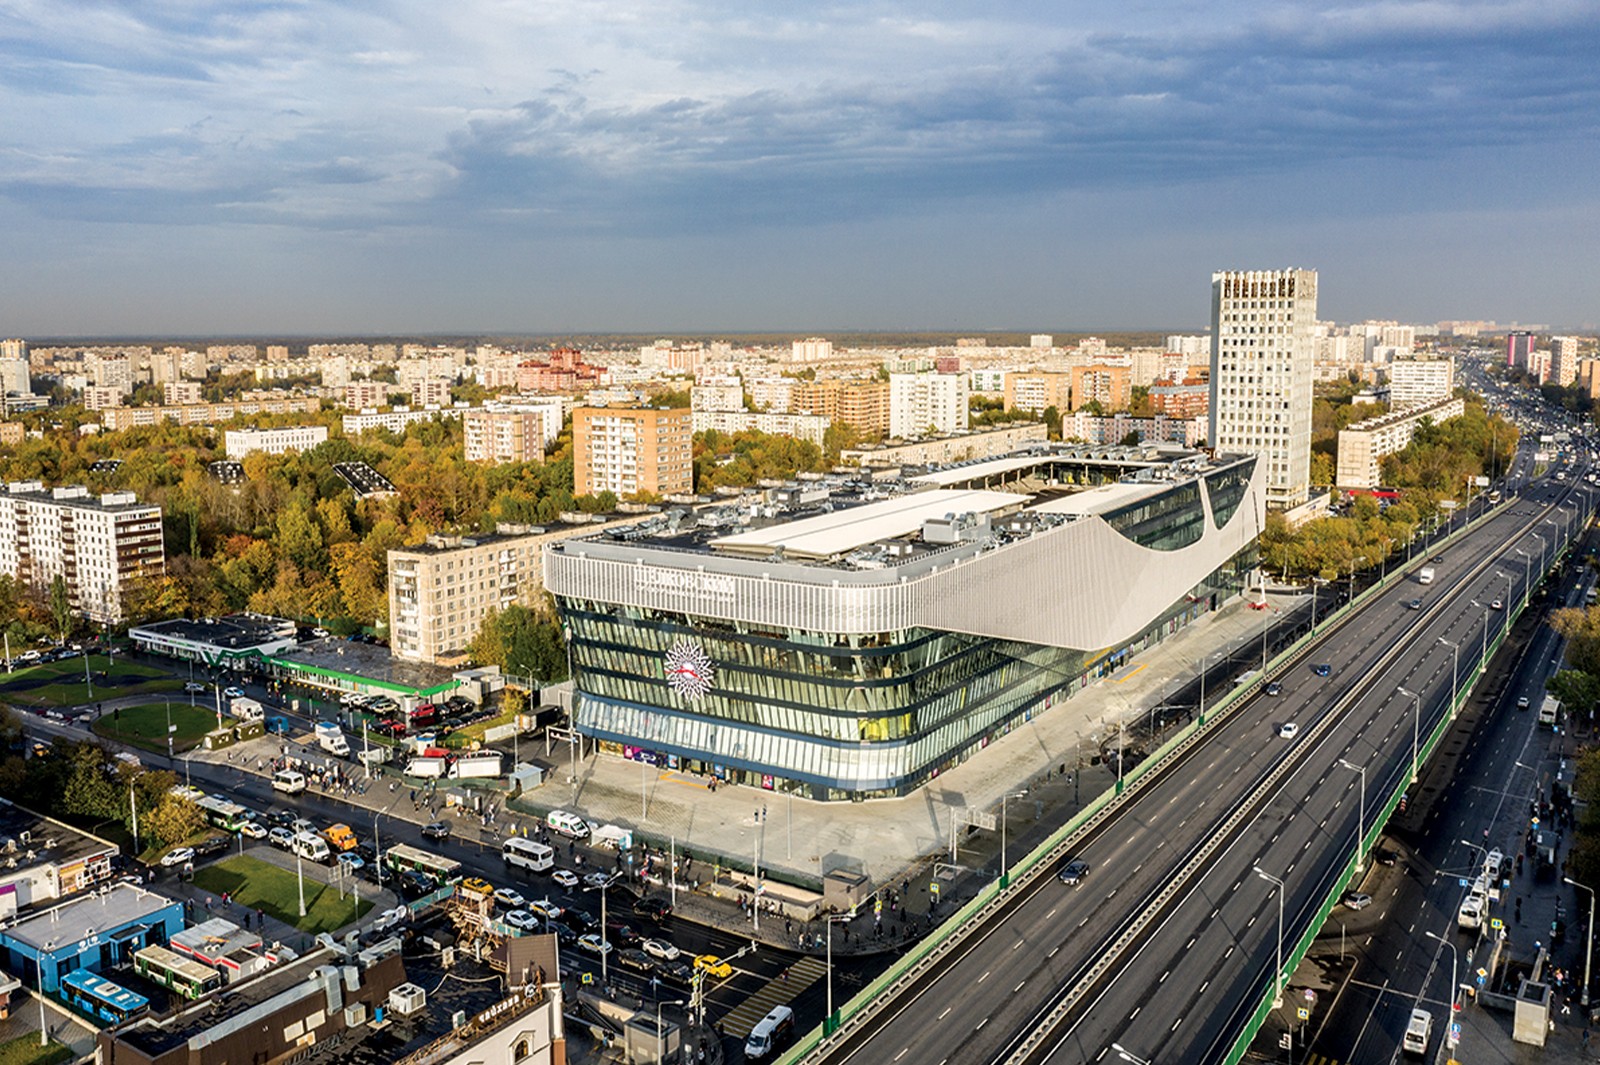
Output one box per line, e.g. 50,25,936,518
546,446,1266,800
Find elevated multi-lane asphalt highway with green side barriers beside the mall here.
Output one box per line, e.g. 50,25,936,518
814,460,1590,1063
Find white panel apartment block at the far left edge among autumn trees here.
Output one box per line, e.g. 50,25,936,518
0,481,166,625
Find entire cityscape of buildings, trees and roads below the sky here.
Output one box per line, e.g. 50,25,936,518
0,278,1600,1065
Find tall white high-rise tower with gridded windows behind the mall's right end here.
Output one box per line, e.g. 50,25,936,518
1211,270,1317,509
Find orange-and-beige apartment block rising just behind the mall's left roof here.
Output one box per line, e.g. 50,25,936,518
573,406,694,499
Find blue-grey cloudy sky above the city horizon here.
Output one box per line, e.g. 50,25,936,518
0,0,1600,337
